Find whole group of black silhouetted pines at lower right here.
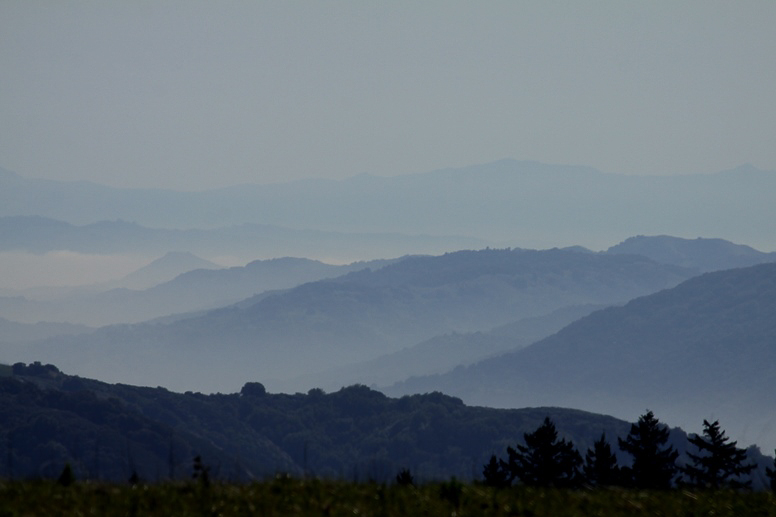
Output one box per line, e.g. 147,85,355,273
482,411,756,490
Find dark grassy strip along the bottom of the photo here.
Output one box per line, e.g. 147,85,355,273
0,478,776,517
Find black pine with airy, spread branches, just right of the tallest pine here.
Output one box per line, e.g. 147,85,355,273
680,420,755,490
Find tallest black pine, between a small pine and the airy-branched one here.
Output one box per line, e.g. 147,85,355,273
617,411,679,489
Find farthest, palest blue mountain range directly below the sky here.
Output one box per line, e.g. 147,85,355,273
0,160,776,251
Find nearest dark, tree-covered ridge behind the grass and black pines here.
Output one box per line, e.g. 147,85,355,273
6,363,773,488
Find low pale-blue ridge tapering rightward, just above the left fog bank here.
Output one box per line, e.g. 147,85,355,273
0,215,488,262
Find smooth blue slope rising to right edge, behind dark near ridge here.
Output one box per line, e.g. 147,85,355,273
388,263,776,449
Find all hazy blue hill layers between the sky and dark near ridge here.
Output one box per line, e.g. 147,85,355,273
0,160,776,472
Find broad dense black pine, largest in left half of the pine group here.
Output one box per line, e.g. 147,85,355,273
507,418,582,487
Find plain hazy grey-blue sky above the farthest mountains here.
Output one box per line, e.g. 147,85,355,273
0,0,776,190
